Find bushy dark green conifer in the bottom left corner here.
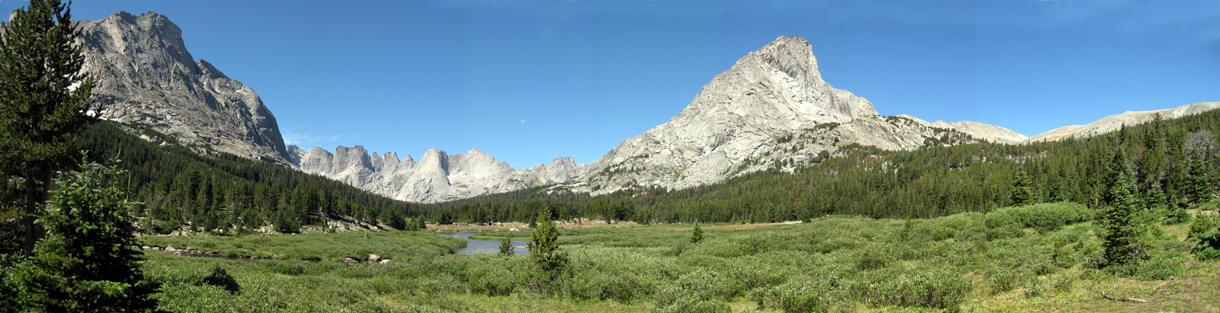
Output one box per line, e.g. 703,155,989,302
5,157,159,312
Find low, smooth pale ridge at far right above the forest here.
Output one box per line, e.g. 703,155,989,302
1025,102,1220,142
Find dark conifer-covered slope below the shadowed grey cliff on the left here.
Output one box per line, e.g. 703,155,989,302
78,122,424,234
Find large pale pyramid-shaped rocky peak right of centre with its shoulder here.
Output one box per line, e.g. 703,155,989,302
560,37,1025,194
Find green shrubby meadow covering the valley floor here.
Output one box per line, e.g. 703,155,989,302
138,203,1220,312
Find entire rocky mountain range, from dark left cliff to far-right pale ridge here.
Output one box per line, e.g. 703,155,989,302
79,12,1220,202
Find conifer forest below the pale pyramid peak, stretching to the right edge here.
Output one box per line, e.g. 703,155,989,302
427,111,1220,223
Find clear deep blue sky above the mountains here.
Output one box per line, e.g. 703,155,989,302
9,0,1220,168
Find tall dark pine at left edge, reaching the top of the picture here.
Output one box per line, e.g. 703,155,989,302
0,0,102,256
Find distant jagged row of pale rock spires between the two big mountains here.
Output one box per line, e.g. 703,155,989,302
287,145,587,203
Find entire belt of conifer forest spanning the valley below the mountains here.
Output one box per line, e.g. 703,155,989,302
79,106,1220,233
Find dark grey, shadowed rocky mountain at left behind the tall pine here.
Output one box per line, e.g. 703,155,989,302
78,12,292,166
